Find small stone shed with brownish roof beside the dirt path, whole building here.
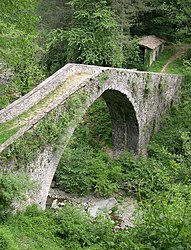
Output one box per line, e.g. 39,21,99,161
138,35,165,67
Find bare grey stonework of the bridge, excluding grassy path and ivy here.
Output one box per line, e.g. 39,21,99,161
0,65,182,208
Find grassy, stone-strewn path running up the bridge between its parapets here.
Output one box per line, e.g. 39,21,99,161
0,72,92,152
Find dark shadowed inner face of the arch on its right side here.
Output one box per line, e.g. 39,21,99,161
101,90,139,156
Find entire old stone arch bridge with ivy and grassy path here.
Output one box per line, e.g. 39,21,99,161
0,64,182,208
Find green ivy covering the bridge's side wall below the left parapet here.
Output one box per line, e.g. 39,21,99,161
0,89,88,168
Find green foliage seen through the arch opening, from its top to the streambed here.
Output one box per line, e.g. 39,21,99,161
56,99,121,196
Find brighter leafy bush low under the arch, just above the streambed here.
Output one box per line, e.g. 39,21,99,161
56,128,121,196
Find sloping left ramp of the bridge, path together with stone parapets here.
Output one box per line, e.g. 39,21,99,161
0,64,107,153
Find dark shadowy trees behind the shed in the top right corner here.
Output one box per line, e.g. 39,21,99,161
133,0,191,42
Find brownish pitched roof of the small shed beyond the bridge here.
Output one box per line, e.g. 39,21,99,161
139,35,165,50
